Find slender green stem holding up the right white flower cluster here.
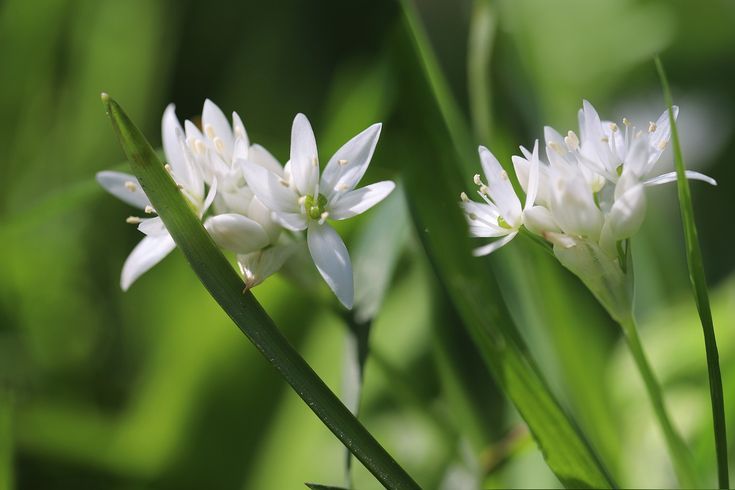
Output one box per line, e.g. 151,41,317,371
620,315,698,488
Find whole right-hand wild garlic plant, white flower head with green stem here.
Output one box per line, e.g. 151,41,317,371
460,101,716,486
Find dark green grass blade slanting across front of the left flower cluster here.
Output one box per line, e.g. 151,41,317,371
102,94,419,489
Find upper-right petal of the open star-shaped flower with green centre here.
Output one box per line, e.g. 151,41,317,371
319,123,382,198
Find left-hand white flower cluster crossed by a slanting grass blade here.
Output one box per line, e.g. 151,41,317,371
102,100,395,308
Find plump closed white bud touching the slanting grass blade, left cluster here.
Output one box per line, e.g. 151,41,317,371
204,213,270,254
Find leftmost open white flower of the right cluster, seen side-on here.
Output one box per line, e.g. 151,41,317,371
460,143,539,256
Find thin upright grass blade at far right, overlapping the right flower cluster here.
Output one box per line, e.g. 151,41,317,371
655,57,729,488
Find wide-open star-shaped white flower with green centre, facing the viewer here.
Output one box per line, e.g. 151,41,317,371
243,114,395,308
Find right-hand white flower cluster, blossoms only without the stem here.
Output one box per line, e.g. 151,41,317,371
461,101,716,260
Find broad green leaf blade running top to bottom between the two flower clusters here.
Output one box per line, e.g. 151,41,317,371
395,0,615,488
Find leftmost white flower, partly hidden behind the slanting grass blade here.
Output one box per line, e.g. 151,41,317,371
97,104,217,291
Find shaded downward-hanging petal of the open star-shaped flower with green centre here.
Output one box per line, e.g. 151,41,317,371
307,221,354,309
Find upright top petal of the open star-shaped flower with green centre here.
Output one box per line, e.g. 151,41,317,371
291,114,319,196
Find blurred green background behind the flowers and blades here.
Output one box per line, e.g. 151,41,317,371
0,0,735,489
